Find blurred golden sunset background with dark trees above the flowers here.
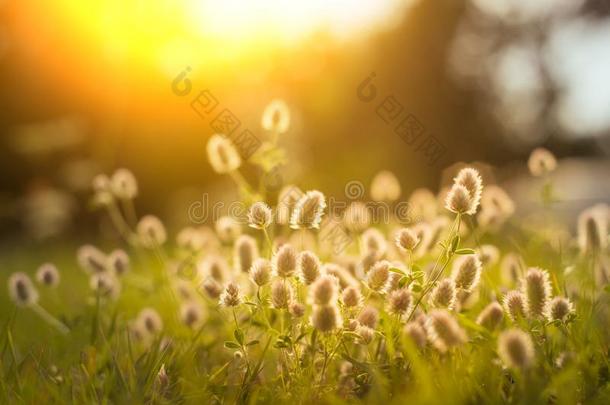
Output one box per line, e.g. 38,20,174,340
0,0,610,246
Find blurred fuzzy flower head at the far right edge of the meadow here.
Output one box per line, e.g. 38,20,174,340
578,204,610,254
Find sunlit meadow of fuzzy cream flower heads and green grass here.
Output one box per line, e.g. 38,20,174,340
0,102,610,404
